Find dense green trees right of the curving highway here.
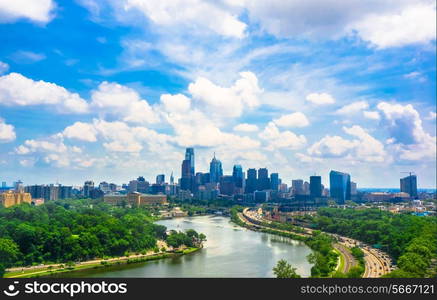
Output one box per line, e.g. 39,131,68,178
307,208,437,277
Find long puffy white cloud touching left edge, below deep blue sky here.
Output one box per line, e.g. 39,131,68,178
0,73,88,113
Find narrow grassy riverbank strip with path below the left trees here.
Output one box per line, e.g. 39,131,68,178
4,247,203,278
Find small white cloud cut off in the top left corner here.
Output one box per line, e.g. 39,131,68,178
0,0,56,23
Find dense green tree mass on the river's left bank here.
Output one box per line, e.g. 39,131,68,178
0,200,166,267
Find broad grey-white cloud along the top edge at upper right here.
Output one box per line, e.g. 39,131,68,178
246,0,436,48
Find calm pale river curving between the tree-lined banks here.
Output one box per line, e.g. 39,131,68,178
64,216,311,278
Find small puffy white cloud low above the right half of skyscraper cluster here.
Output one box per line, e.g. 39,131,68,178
259,122,307,151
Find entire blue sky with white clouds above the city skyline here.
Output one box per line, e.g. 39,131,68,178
0,0,436,188
